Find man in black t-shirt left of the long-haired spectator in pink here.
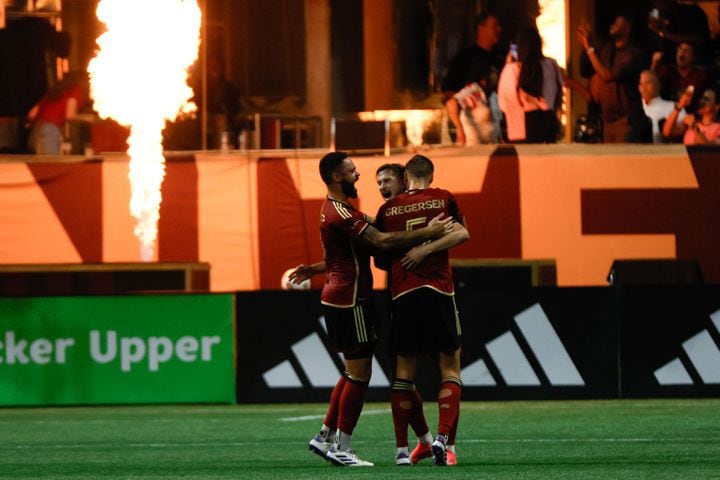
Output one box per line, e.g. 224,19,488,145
442,12,503,145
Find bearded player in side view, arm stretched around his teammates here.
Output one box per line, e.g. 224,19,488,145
309,152,452,467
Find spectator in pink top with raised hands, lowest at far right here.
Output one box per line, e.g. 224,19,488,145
663,88,720,145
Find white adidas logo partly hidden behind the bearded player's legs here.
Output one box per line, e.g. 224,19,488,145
263,316,390,388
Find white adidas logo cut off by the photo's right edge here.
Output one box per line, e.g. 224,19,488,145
655,310,720,385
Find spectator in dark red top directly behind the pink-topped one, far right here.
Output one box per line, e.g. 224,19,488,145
651,41,710,111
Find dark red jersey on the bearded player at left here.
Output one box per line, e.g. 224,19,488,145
320,198,372,307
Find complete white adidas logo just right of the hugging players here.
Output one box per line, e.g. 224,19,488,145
462,303,585,387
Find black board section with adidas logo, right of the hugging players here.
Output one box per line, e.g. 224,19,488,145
456,288,618,400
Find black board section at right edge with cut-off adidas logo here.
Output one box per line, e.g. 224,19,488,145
618,286,720,397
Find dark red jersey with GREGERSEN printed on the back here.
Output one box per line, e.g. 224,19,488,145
376,188,462,299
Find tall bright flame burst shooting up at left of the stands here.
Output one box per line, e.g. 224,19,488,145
88,0,201,262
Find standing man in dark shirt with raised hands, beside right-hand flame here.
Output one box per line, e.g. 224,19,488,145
577,15,652,143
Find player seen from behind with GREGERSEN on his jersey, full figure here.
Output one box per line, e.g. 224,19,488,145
376,155,470,465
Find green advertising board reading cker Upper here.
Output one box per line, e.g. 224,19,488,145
0,294,235,405
